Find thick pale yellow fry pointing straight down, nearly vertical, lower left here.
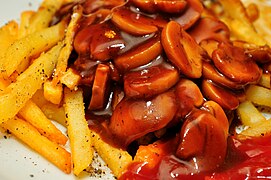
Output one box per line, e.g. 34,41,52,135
64,88,94,176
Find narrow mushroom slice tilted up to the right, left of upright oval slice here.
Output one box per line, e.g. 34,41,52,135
114,36,162,72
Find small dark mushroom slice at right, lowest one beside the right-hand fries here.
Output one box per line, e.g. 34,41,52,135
202,79,239,110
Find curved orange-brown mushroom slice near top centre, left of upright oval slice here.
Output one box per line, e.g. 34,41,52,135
111,7,158,36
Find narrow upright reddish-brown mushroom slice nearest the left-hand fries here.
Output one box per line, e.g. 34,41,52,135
88,64,110,110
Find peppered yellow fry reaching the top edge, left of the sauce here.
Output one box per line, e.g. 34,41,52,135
27,0,63,34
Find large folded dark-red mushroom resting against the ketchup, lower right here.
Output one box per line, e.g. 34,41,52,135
176,109,227,173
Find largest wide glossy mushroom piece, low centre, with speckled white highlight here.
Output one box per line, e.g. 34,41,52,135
109,91,177,147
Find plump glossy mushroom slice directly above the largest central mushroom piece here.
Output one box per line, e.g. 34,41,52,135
124,64,179,98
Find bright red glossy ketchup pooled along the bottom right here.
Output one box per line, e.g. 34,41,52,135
120,136,271,180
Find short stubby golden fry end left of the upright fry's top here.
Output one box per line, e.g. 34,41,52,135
43,80,63,104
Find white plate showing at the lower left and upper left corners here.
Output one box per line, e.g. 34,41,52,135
0,0,114,180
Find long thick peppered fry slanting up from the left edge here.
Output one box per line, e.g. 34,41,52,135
0,44,62,122
